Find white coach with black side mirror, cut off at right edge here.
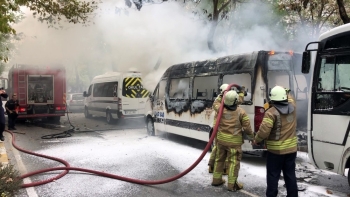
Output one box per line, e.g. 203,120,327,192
302,24,350,184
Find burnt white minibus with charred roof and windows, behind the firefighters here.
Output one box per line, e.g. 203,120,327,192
145,51,310,156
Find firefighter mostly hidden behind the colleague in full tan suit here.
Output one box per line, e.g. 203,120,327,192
208,83,246,175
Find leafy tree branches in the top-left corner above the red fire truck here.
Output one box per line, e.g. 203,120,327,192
0,0,97,62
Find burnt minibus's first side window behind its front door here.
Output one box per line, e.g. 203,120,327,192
169,78,190,99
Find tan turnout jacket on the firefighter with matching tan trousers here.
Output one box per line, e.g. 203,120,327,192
213,96,254,147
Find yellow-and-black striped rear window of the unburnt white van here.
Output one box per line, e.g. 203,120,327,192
122,77,149,98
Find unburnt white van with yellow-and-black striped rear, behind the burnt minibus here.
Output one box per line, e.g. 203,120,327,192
84,71,149,123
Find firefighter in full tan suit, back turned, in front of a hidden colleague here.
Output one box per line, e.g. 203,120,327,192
211,90,254,191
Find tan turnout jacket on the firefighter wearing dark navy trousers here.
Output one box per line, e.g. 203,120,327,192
255,94,297,155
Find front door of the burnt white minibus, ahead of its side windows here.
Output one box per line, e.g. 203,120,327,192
152,80,167,132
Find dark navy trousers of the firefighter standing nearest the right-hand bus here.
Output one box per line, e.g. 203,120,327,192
266,152,298,197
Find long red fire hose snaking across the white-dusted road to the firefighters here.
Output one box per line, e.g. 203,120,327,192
6,84,239,188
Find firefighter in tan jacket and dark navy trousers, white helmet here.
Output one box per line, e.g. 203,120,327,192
252,86,298,197
